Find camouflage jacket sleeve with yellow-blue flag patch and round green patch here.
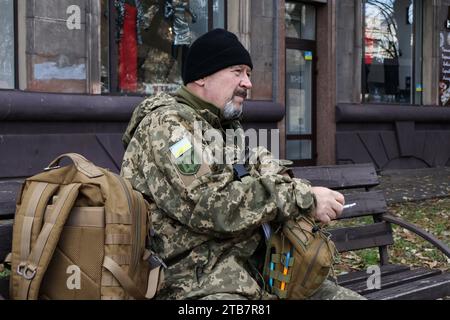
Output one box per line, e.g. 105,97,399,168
141,114,314,237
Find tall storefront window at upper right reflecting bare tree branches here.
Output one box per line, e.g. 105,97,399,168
362,0,423,104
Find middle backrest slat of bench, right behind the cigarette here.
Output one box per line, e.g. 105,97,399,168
338,191,387,220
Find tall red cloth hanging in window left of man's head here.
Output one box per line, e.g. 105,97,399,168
119,3,138,92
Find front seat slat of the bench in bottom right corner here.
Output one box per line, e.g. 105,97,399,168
365,273,450,300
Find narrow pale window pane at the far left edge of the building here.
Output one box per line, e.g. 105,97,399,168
0,0,15,89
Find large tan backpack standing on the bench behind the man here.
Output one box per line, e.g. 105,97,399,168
10,153,162,300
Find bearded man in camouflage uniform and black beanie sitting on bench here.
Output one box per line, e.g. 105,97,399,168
121,29,366,299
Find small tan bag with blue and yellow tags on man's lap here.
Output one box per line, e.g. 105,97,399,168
264,216,337,300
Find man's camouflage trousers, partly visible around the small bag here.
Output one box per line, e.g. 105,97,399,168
202,280,367,300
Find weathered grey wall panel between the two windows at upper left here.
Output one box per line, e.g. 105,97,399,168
19,0,100,93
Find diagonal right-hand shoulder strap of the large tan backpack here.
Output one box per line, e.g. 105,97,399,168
16,183,81,300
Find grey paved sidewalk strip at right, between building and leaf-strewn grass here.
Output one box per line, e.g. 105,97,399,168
376,167,450,203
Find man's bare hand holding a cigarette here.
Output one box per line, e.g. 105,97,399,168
311,187,345,224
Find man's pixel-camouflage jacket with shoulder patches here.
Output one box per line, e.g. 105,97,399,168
121,87,314,299
